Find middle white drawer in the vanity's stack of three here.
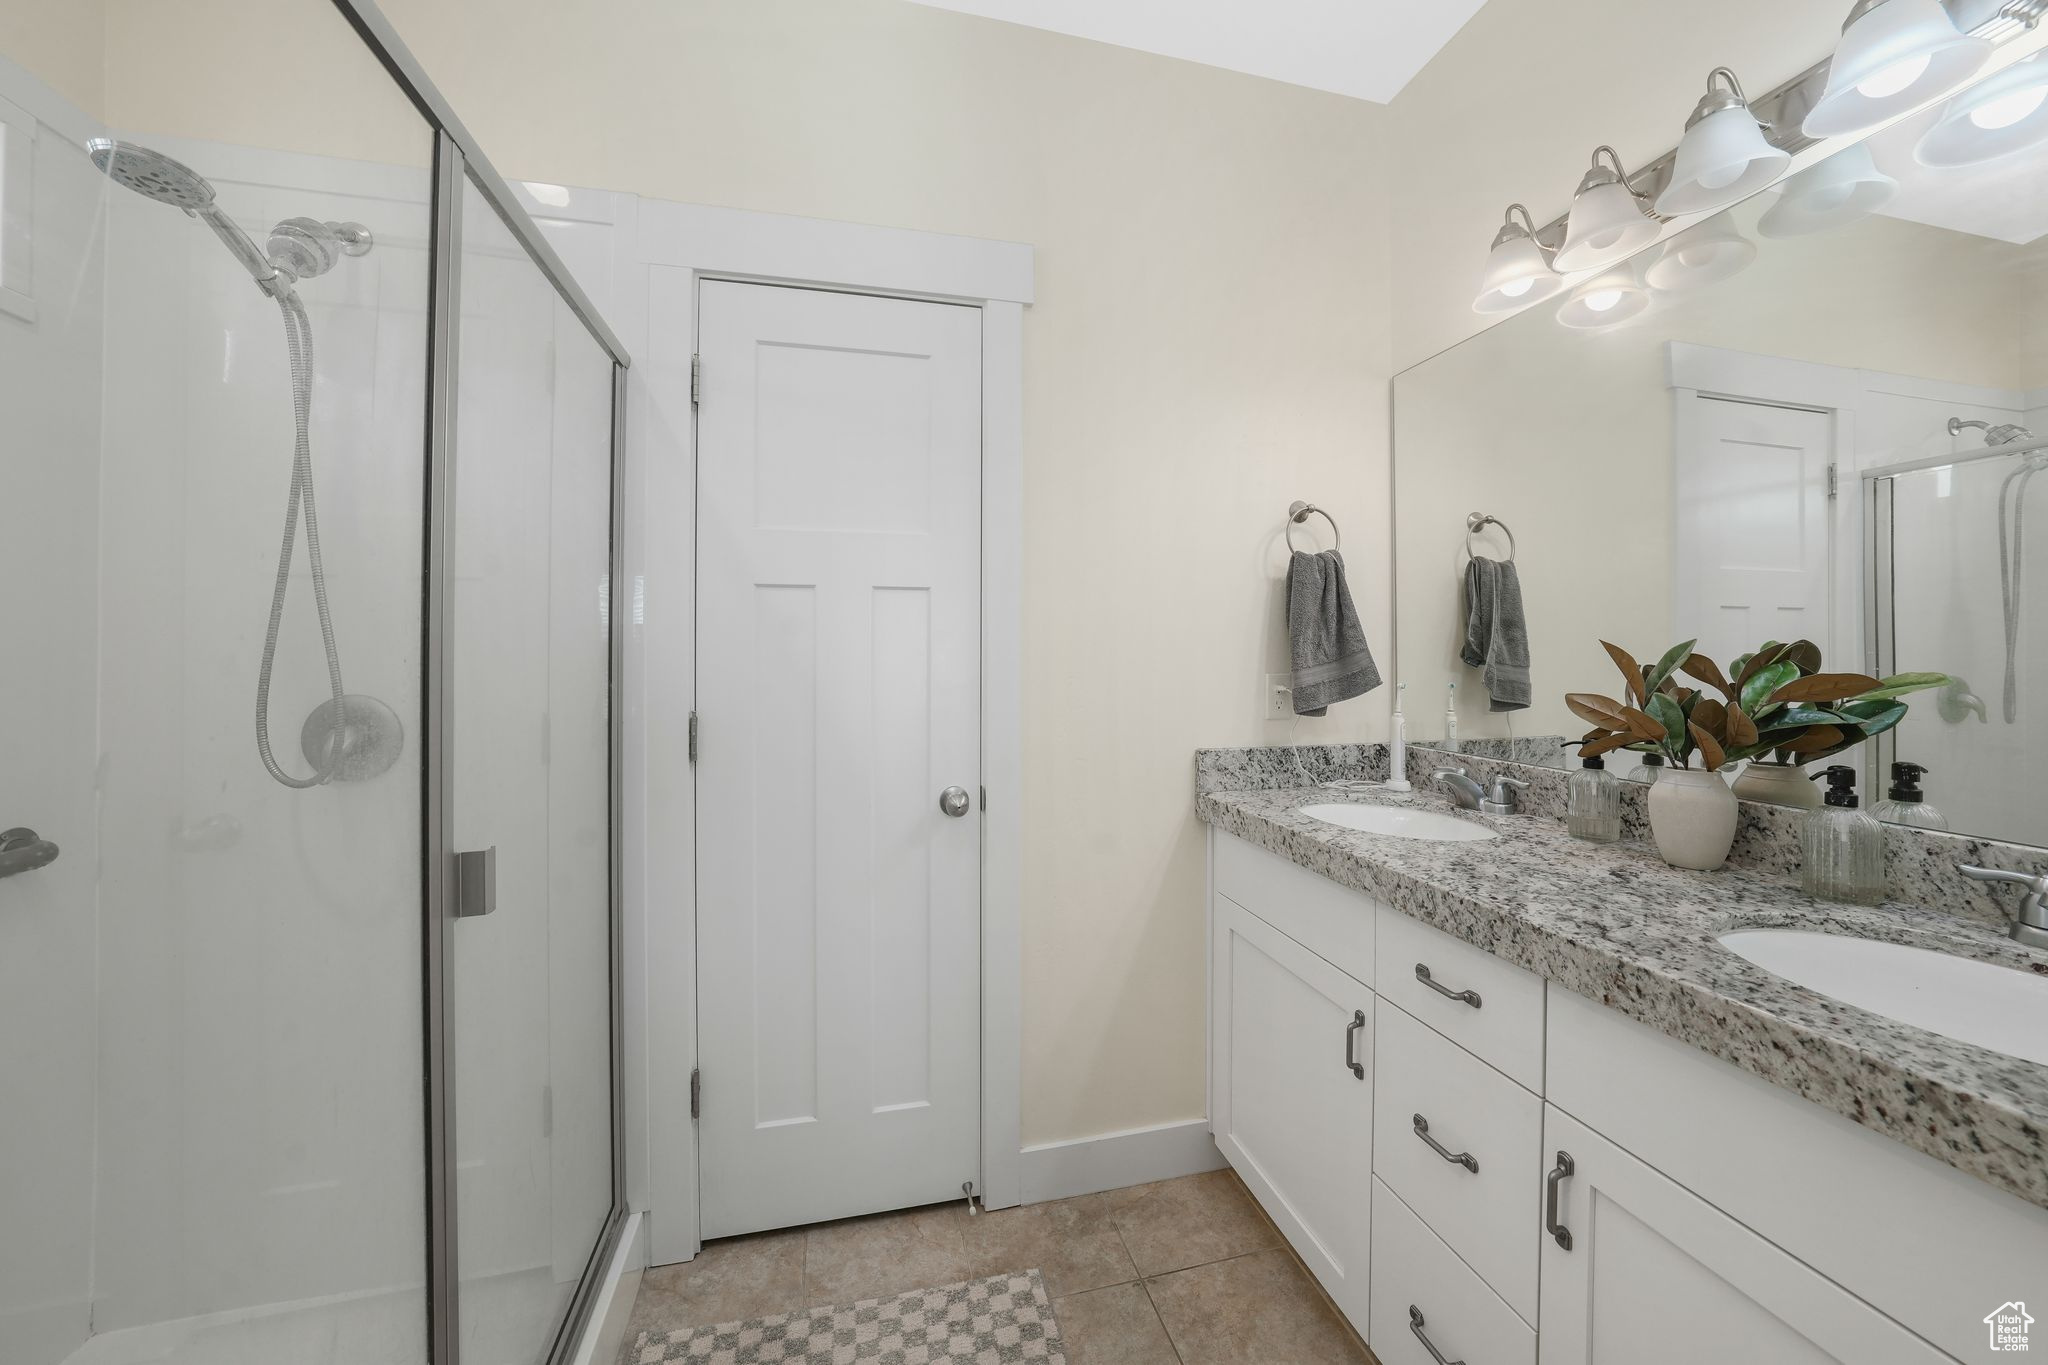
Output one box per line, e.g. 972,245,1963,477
1372,1001,1544,1322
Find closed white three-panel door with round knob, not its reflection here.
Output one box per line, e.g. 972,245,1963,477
696,282,981,1238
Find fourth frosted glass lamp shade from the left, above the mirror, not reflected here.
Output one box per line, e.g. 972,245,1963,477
1804,0,1991,137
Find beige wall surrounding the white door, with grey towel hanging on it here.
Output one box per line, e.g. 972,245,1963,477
83,0,1393,1144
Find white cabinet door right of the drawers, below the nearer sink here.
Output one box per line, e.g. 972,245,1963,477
1538,1105,1948,1365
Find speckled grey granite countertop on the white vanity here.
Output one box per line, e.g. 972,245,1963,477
1196,786,2048,1207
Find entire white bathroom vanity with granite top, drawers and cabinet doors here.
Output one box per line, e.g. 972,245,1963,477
1196,765,2048,1365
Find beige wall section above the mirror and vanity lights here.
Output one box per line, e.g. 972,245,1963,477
1389,0,1849,368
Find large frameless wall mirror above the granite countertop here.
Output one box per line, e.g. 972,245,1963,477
1395,61,2048,845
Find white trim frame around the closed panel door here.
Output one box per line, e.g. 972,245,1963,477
623,201,1034,1265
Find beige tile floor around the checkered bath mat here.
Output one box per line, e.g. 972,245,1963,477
623,1171,1372,1365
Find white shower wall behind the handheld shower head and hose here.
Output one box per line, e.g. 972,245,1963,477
94,135,440,1332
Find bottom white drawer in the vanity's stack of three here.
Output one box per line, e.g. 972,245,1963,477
1366,1179,1536,1365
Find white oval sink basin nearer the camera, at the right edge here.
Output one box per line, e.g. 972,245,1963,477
1720,929,2048,1064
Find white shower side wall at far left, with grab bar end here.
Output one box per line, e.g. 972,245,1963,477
0,63,104,1365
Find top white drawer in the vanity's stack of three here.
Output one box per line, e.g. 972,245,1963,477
1374,909,1542,1095
